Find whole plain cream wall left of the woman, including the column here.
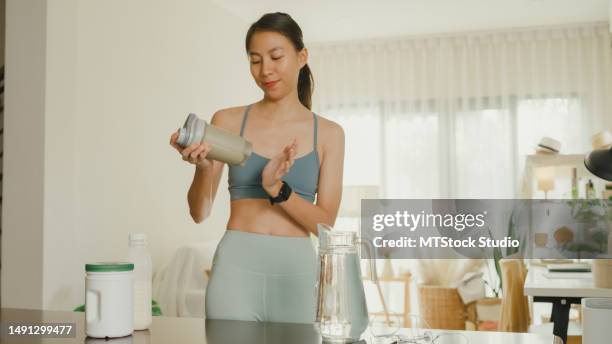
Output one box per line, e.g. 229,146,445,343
2,0,259,309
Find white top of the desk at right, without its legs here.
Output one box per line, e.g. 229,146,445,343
524,265,612,297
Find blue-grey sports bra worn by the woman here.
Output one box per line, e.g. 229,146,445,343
228,105,320,202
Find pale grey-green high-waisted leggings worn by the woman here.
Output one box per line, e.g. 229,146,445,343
206,229,317,323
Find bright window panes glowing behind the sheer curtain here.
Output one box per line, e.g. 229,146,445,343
323,97,589,198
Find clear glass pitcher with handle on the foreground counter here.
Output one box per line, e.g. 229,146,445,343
315,224,377,343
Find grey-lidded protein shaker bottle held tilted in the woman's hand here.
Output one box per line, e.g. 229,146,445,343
176,113,252,165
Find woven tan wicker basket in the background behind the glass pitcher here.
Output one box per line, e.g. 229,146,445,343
418,284,467,330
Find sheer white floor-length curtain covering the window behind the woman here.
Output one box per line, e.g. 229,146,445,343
309,23,612,198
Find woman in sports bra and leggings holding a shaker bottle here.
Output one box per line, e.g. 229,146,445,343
170,13,344,323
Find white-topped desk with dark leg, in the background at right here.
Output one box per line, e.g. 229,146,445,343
524,266,612,343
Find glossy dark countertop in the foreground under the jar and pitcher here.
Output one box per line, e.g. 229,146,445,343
0,308,558,344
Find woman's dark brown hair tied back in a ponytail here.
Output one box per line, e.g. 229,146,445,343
245,12,314,110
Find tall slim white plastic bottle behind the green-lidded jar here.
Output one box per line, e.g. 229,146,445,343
128,233,153,330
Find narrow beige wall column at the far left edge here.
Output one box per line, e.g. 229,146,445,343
0,0,46,308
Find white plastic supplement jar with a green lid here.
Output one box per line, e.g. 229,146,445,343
85,262,134,338
